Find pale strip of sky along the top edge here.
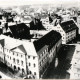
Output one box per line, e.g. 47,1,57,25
0,0,80,7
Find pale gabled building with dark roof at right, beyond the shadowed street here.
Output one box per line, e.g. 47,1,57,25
57,20,78,44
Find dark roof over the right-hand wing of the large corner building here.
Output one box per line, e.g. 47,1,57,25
33,30,61,52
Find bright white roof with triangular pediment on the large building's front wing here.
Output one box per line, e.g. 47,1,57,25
0,35,37,56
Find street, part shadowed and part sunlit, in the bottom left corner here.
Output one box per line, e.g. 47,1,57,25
0,62,23,79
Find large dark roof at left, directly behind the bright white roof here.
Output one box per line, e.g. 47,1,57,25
9,23,30,39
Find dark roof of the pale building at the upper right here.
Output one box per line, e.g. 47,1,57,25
60,20,77,33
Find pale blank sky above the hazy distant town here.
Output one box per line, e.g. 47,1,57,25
0,0,80,8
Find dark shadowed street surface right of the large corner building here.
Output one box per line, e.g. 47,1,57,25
44,45,75,79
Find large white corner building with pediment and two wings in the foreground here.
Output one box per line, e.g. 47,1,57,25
0,30,62,79
